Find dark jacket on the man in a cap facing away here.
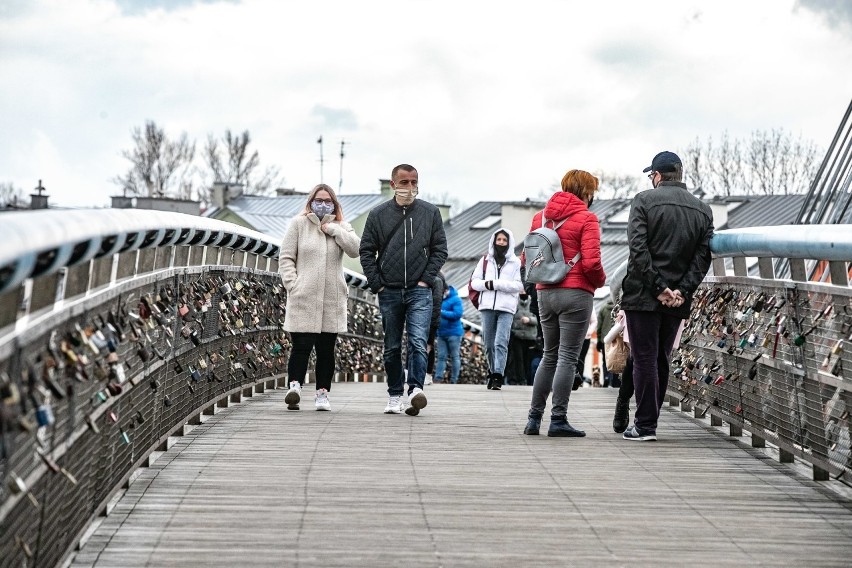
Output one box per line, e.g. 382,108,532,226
621,181,713,318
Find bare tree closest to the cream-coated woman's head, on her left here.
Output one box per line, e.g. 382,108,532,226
202,130,284,201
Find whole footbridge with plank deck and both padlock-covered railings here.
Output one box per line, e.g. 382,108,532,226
0,211,852,567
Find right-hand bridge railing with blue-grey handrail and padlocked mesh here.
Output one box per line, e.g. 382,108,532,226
669,225,852,483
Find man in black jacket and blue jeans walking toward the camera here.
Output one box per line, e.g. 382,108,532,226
360,164,447,416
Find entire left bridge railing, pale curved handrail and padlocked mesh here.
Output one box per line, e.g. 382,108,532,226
0,210,482,566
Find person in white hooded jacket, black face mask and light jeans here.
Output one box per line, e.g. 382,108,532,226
470,227,524,390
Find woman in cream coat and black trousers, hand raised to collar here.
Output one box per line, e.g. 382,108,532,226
278,184,360,410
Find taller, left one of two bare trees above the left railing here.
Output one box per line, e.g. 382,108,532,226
113,120,195,199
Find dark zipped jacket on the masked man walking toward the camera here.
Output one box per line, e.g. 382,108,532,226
359,199,447,293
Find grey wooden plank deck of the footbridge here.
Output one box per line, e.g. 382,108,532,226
70,383,852,567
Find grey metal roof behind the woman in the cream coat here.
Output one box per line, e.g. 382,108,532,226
204,193,387,238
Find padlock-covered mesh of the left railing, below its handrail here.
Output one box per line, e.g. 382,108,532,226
0,267,481,566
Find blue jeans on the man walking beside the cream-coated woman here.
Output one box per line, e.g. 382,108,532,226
379,286,432,396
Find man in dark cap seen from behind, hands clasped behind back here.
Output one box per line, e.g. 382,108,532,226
621,152,713,441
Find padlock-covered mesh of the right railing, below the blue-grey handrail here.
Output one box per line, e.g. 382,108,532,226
669,284,852,467
